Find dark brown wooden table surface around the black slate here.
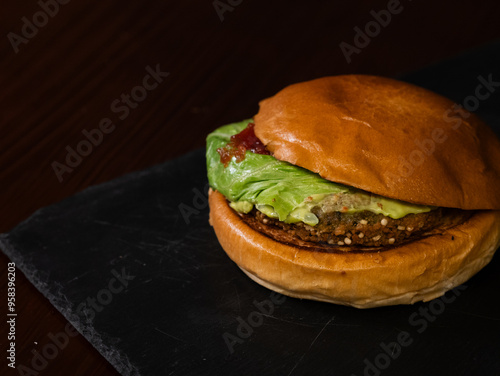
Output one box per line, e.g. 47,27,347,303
0,0,500,375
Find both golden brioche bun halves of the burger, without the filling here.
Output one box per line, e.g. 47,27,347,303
209,75,500,308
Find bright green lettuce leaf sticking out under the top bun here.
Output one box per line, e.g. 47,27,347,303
206,119,430,222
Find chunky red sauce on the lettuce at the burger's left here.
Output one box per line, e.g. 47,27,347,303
217,123,270,167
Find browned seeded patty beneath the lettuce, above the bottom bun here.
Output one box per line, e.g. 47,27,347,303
238,208,471,252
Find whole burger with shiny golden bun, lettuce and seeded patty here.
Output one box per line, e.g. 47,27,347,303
206,75,500,308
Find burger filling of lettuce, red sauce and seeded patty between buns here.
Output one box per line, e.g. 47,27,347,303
207,120,467,248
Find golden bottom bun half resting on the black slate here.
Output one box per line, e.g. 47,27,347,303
209,190,500,308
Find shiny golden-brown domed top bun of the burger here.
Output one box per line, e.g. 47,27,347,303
254,75,500,210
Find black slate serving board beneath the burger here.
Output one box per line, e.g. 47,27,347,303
0,44,500,375
